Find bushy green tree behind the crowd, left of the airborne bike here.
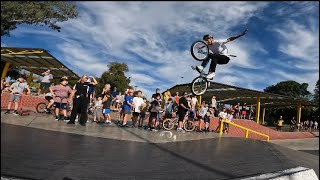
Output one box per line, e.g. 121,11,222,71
96,62,132,94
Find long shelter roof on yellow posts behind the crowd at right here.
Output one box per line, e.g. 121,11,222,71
168,82,317,107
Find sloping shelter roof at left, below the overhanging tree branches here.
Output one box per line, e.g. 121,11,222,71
1,47,80,79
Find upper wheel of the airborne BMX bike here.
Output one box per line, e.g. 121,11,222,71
191,41,209,61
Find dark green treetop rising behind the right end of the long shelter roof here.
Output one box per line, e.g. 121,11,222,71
264,81,311,98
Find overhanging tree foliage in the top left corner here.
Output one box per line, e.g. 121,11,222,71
1,1,78,36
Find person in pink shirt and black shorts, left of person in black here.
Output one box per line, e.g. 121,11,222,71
49,76,72,121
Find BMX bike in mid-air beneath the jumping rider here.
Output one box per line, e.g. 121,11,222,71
191,41,236,96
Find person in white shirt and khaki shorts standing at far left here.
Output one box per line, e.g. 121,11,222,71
5,75,30,115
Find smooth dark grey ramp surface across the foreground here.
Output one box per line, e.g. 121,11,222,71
1,123,319,180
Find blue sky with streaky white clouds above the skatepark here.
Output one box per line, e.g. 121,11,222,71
1,1,319,97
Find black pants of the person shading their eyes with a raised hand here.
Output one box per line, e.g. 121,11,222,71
70,95,89,124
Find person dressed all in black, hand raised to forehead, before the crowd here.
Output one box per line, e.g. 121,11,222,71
67,75,89,126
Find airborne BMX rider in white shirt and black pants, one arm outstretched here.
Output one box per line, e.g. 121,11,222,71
196,29,247,80
